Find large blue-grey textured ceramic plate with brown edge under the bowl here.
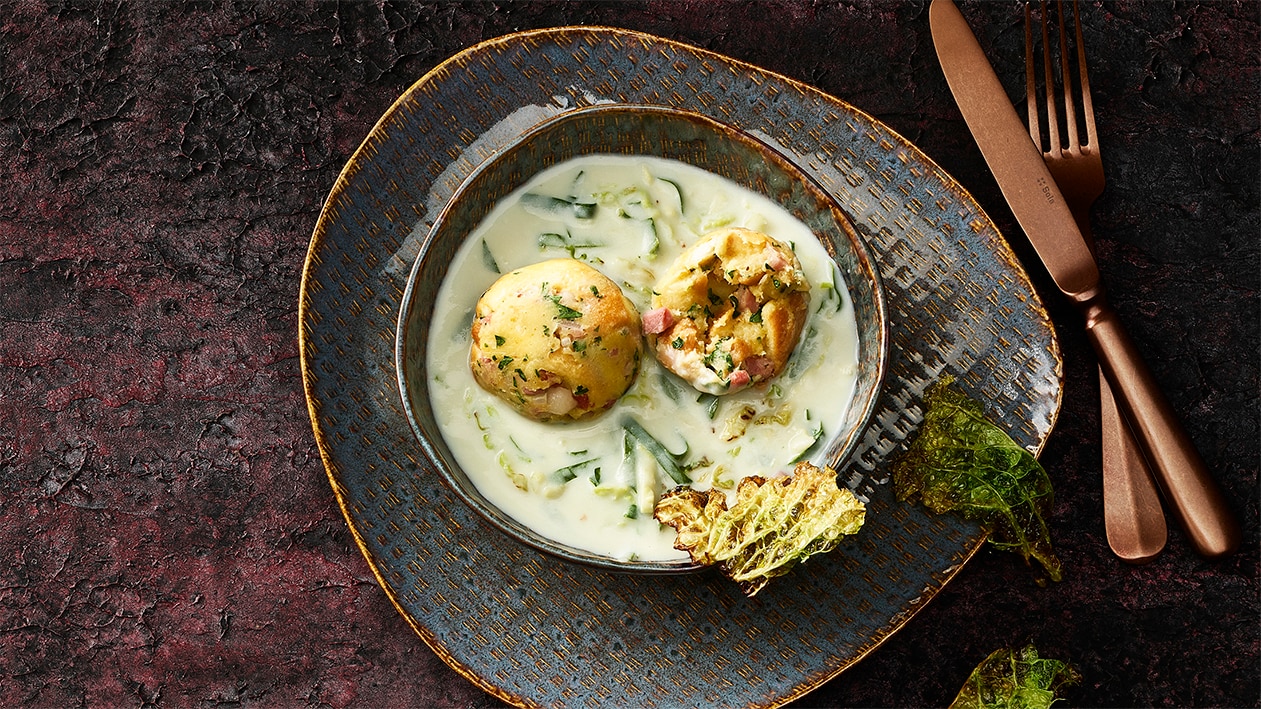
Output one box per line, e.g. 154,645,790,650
299,28,1062,706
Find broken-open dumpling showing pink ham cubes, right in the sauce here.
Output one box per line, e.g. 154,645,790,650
643,227,810,394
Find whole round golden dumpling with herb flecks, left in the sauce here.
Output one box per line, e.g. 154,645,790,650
469,259,642,421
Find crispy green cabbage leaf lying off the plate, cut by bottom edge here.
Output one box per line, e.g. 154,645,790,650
950,645,1082,709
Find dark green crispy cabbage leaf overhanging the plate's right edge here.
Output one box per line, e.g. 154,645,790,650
893,377,1062,584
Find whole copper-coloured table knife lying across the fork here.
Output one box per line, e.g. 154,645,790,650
928,0,1241,556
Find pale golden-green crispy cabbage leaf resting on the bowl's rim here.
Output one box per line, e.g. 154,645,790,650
654,462,866,598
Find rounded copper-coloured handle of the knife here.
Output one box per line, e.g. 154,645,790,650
1079,291,1241,556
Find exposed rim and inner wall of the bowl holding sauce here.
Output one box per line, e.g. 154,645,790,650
396,105,889,573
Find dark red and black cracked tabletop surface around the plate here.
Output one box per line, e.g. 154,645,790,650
0,1,1261,706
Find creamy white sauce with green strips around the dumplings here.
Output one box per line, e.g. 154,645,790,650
426,155,857,560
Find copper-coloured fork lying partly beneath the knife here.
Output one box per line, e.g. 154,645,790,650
1025,0,1168,564
